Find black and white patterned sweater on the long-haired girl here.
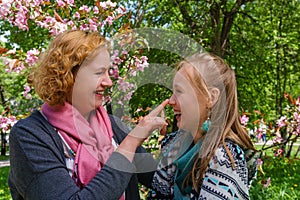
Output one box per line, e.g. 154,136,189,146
148,131,257,200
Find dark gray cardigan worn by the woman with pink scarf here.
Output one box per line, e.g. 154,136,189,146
8,111,157,200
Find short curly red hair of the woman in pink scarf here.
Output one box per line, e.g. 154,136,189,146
28,30,108,106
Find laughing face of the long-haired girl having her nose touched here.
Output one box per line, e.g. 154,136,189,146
169,64,208,135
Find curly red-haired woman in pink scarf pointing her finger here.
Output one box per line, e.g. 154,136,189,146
9,30,168,200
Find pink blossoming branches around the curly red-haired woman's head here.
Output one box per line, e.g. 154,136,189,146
0,0,148,155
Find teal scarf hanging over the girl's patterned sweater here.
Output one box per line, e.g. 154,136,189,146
174,141,201,200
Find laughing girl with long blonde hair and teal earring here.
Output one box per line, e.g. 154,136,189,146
148,53,256,199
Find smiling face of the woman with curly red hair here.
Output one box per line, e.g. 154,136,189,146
72,48,112,118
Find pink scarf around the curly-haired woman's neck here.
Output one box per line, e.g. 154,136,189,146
42,103,113,188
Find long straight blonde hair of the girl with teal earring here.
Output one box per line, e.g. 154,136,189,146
179,52,255,191
